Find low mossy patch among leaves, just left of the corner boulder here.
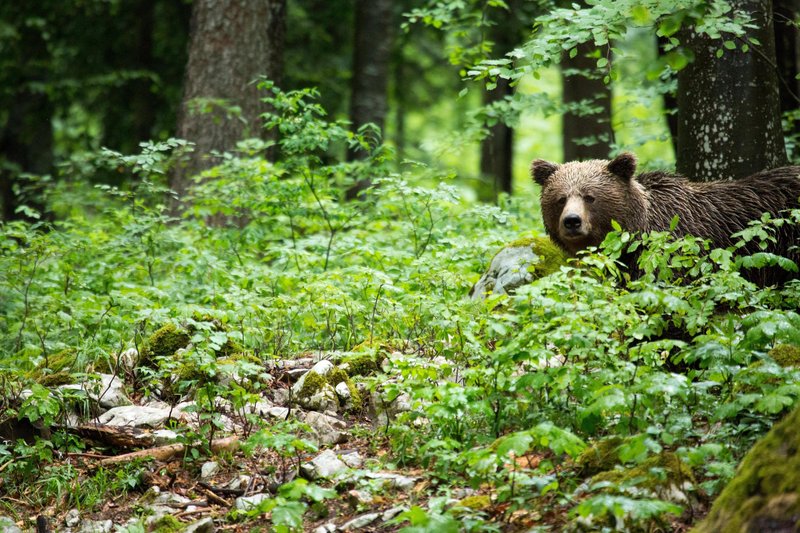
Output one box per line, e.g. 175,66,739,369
592,452,695,496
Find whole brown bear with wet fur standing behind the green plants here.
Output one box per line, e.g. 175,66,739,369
531,153,800,284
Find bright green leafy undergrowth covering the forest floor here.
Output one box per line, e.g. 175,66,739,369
0,83,800,531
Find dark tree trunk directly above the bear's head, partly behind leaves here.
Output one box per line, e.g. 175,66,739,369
561,43,614,161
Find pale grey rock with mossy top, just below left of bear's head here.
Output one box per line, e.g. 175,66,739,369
470,236,564,300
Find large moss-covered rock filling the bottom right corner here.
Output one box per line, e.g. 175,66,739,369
693,407,800,533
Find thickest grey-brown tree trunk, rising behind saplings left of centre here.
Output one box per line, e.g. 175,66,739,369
170,0,286,210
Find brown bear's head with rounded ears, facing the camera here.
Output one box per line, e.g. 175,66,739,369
531,153,643,255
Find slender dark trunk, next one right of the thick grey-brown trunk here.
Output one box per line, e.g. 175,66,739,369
347,0,394,199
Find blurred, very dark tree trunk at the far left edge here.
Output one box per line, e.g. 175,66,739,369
0,20,54,220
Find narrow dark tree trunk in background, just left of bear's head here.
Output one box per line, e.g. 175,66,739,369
481,78,514,197
